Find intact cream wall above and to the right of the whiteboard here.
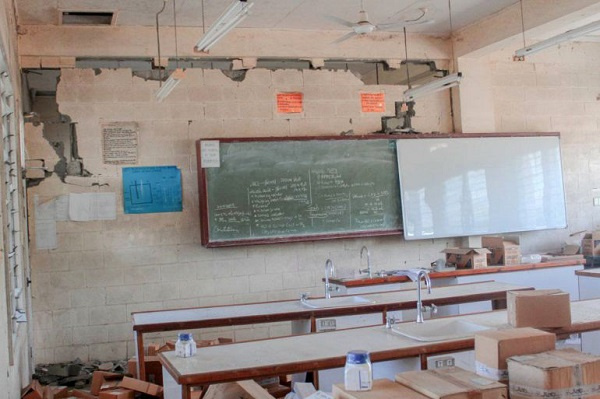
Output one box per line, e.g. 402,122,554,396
460,43,600,253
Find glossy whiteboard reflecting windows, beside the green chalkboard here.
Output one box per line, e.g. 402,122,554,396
396,136,567,240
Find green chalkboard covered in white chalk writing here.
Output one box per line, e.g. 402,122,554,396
197,137,402,246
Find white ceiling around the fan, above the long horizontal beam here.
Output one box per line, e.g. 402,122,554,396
16,0,518,36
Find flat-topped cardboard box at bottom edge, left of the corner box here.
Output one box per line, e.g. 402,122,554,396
396,367,507,399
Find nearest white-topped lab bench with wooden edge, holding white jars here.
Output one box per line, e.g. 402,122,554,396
159,299,600,399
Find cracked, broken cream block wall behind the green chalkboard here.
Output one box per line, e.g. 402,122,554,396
26,69,453,363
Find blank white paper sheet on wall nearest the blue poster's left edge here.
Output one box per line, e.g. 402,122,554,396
69,193,117,222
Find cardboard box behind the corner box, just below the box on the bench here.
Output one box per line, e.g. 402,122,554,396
475,327,556,382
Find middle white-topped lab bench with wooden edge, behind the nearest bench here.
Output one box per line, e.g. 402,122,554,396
132,281,532,379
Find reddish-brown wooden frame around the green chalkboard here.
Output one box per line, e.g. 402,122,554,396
196,135,403,248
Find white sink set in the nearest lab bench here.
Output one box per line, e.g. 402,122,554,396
391,320,490,342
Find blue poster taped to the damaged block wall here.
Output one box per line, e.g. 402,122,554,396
123,166,182,213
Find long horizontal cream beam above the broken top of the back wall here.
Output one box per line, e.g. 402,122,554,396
19,25,450,60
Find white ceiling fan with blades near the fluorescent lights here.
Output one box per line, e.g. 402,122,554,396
327,0,434,44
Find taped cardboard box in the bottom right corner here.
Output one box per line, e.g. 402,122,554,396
508,348,600,399
